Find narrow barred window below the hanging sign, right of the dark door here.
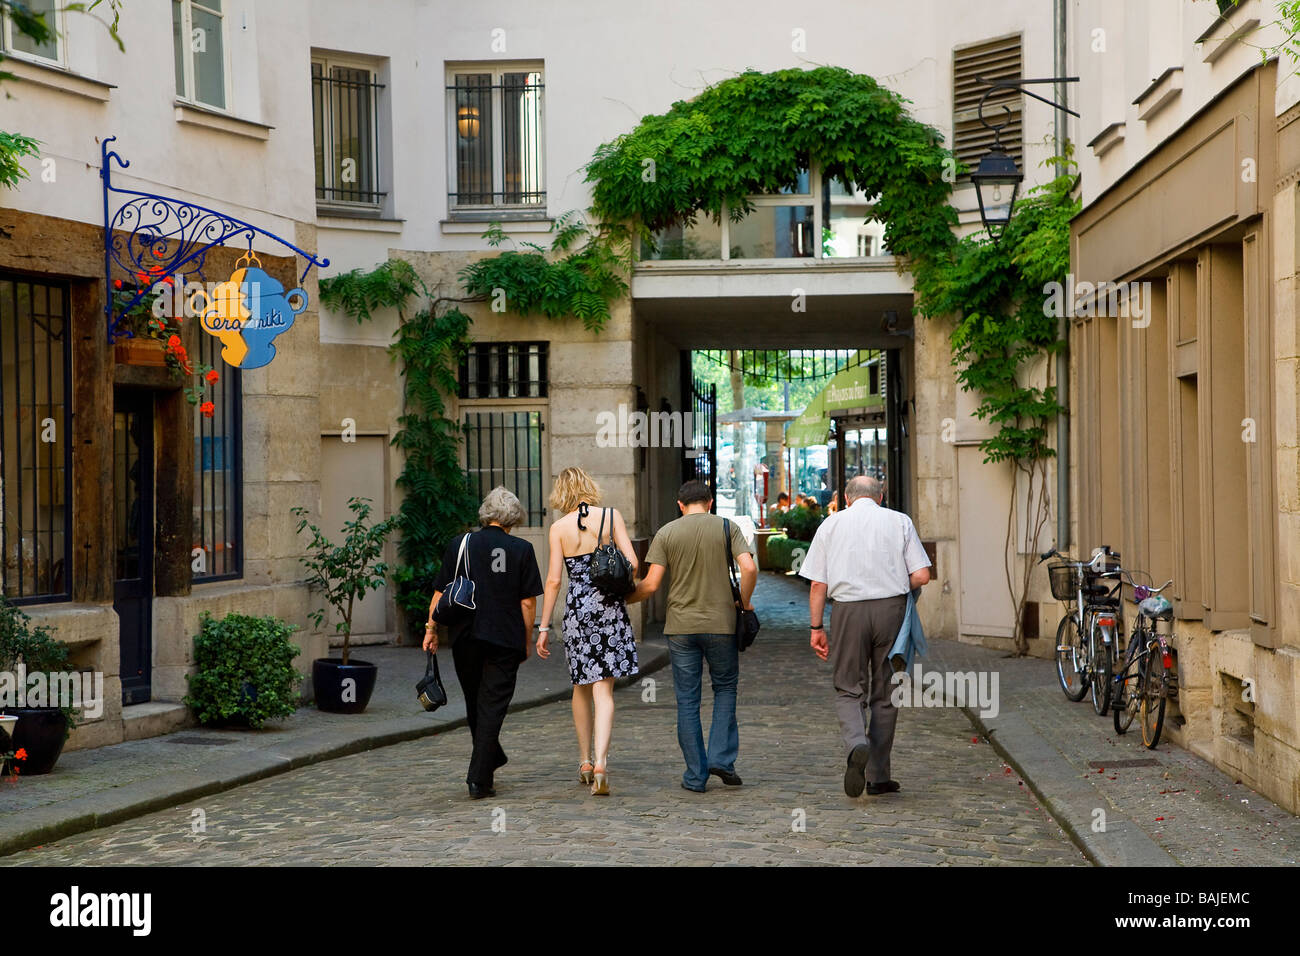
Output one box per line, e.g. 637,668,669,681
190,336,243,581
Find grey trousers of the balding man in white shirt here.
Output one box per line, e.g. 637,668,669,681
831,594,907,783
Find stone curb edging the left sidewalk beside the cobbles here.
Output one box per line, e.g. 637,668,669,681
0,643,668,856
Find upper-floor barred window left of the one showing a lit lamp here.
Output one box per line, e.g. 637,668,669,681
312,59,387,208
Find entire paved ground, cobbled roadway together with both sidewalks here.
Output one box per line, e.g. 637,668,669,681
0,574,1300,865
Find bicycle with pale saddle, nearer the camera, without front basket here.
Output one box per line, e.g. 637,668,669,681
1113,575,1178,750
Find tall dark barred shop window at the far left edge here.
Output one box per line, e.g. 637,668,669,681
0,273,73,604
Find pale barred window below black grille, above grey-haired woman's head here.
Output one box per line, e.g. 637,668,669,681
464,408,546,527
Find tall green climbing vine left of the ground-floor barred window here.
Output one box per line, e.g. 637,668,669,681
320,259,476,639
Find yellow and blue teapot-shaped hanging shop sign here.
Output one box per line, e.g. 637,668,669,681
190,251,307,368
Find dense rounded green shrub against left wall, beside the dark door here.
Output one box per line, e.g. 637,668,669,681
185,613,302,730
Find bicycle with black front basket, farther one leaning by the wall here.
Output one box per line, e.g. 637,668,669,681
1039,545,1122,717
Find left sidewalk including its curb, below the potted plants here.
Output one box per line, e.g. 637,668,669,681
0,632,667,855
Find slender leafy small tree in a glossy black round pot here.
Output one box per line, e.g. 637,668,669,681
291,497,397,714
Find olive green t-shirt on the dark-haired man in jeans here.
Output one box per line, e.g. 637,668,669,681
646,512,749,633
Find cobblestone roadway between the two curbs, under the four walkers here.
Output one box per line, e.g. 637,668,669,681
0,575,1086,865
